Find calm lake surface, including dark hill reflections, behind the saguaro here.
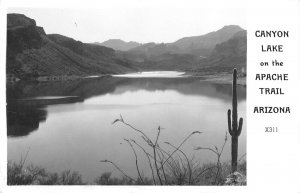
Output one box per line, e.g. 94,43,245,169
7,74,247,182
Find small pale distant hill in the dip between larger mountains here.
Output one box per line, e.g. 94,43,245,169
94,39,141,51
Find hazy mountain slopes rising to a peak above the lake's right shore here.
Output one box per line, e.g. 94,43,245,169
118,25,247,71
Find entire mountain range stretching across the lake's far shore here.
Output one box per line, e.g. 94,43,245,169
6,14,247,79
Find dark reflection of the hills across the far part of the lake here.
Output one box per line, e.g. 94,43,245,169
7,77,246,137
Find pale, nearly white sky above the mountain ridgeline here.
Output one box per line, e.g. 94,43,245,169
8,1,246,43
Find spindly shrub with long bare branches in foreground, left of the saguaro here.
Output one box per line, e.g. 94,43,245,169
97,115,246,185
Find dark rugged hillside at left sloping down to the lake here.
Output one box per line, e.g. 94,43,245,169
7,14,134,79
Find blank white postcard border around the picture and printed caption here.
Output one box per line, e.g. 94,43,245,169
0,0,300,193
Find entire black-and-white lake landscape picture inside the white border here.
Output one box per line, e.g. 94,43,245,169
6,6,247,186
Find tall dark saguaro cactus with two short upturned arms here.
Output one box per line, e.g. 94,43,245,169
227,69,243,172
